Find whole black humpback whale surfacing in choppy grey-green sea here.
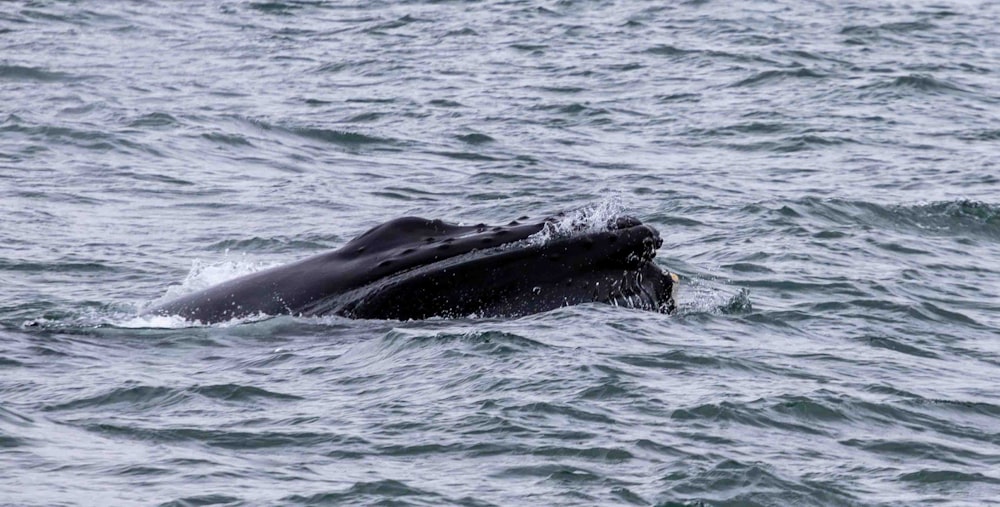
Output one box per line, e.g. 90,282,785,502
143,214,678,324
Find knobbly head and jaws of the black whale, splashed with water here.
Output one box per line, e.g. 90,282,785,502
322,217,678,320
